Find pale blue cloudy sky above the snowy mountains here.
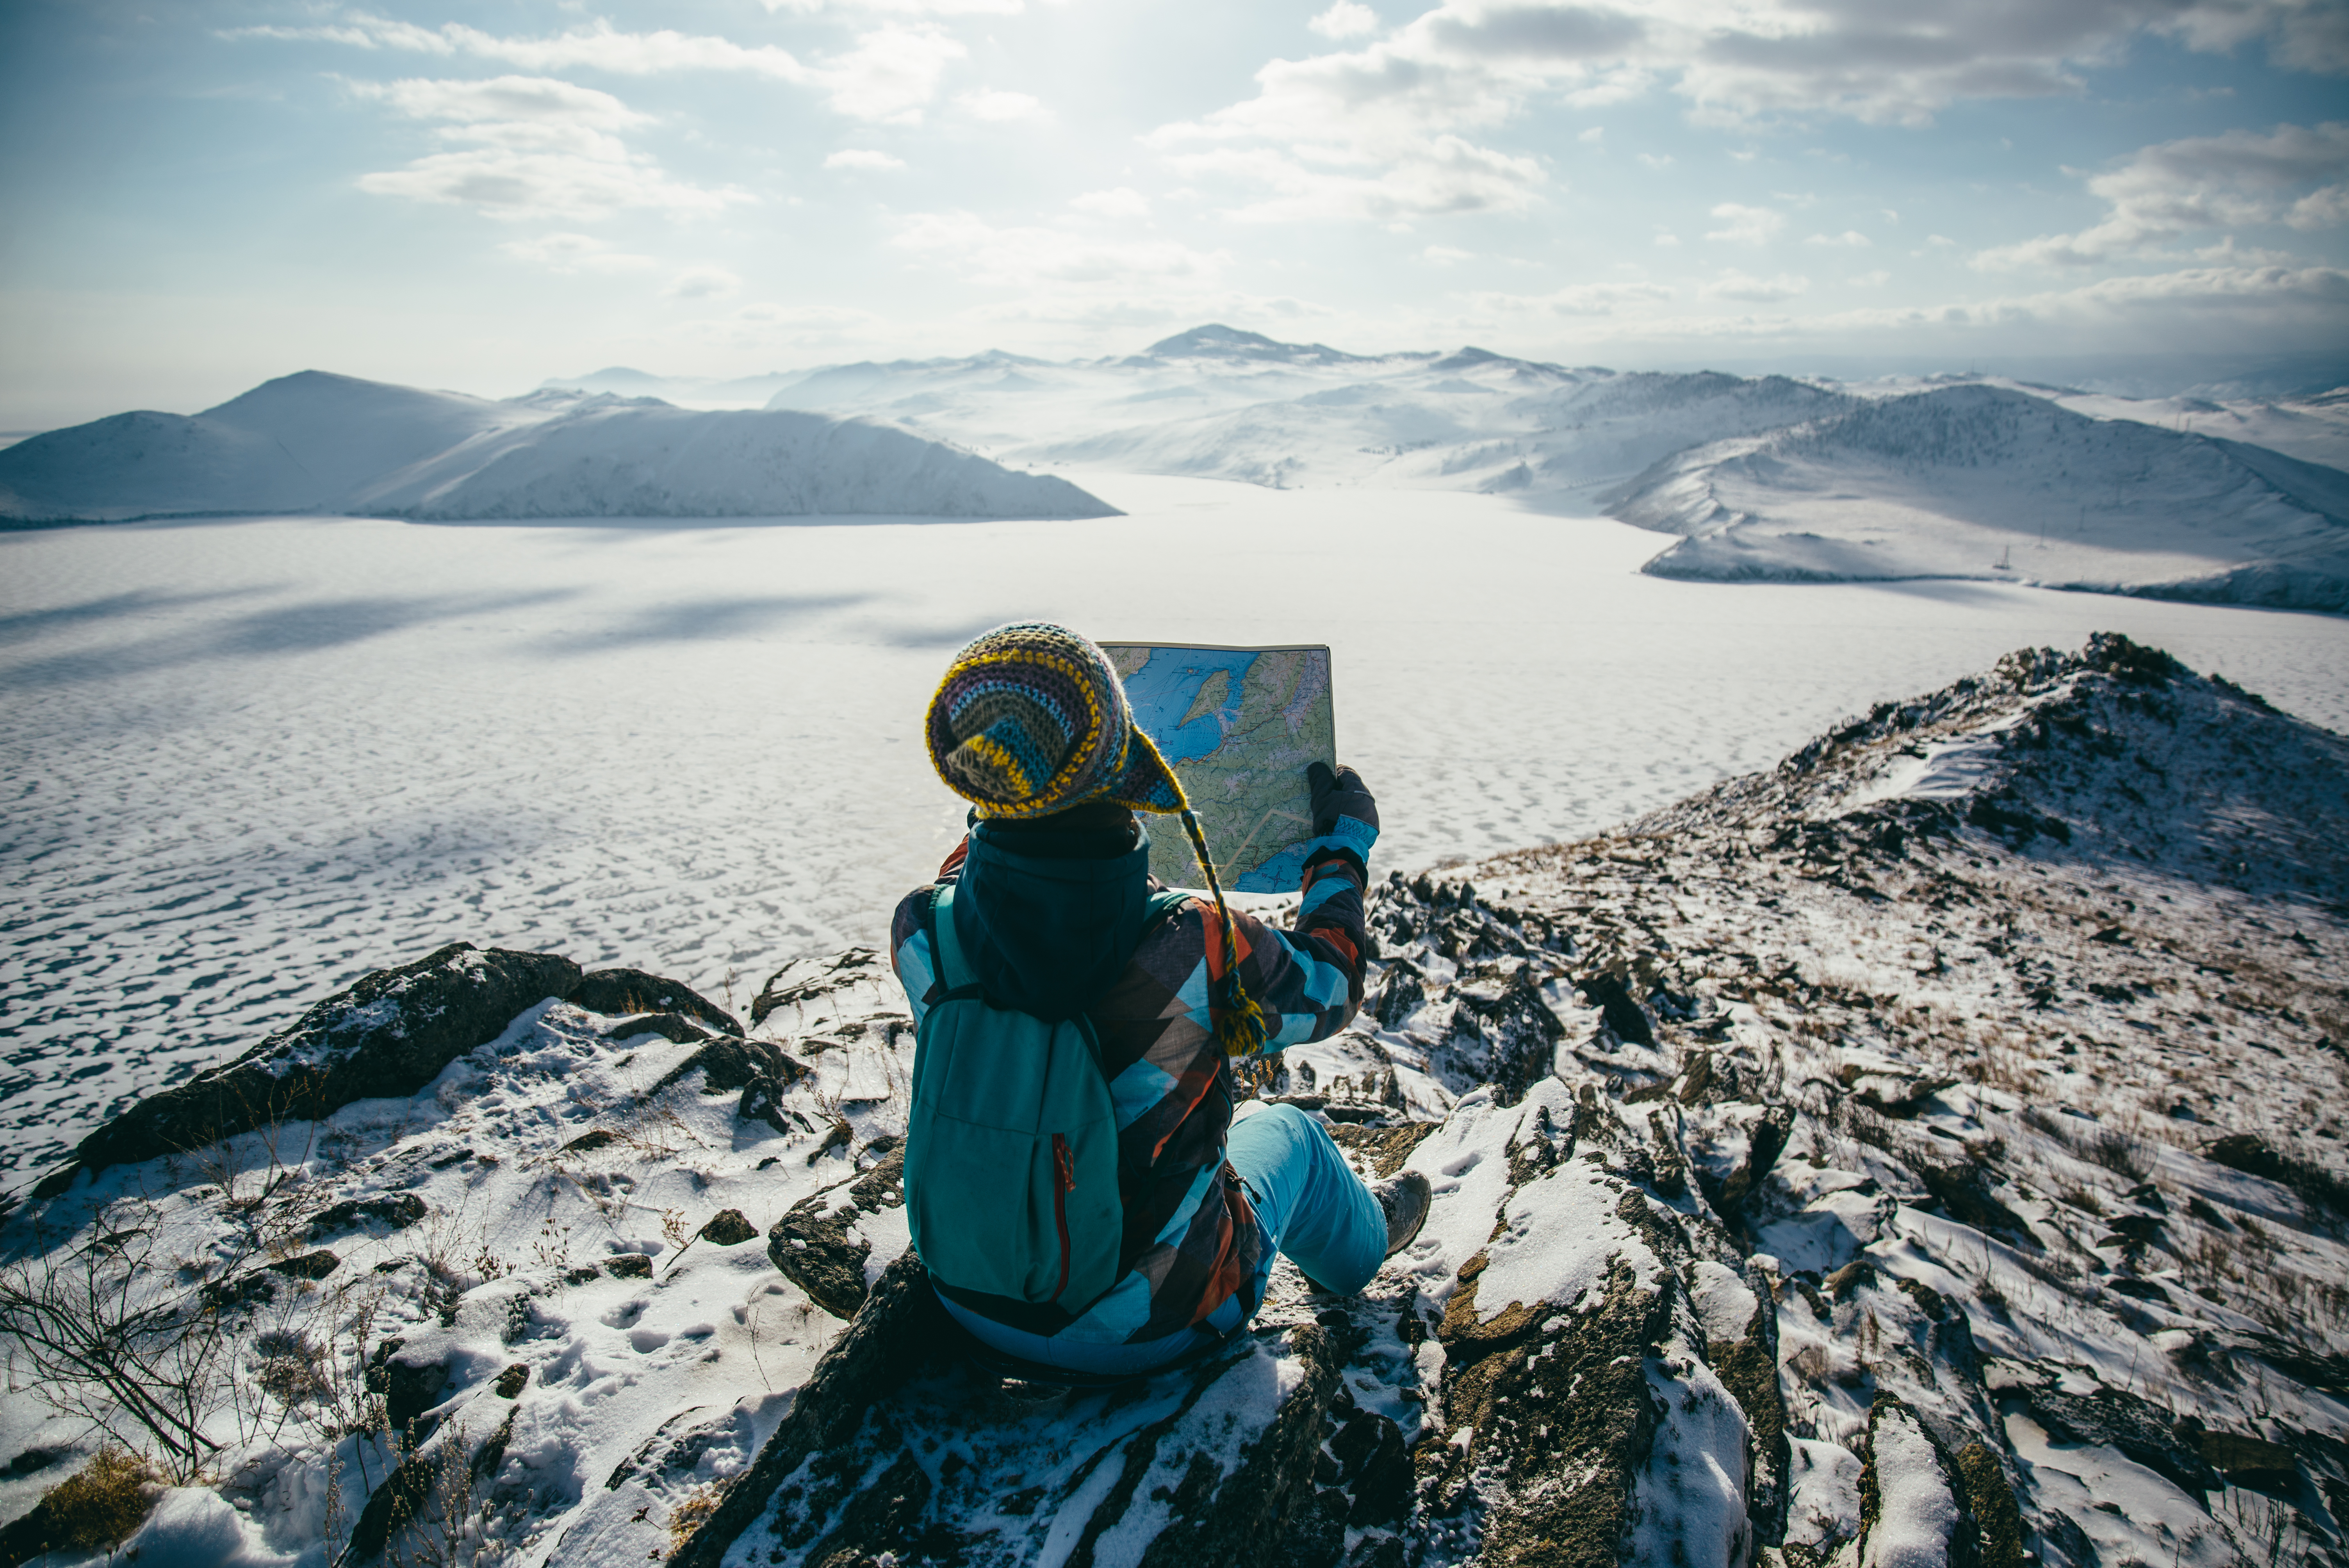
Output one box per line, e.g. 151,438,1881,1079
0,0,2349,429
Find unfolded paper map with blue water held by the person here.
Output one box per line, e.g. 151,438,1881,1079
1102,643,1337,892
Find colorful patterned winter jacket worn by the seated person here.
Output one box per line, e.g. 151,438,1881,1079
890,821,1372,1343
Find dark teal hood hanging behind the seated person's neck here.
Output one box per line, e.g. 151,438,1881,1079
951,821,1151,1023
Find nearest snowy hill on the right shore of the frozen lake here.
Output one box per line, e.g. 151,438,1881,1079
1611,385,2349,610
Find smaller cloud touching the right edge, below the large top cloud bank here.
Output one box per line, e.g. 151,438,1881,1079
1973,122,2349,267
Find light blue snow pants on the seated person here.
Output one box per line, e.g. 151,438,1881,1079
937,1101,1386,1376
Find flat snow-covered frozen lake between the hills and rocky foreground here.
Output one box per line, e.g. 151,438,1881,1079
0,474,2349,1171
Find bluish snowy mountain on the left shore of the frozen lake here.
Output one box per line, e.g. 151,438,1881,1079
0,371,1114,524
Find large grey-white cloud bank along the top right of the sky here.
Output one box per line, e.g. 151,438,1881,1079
1149,0,2349,223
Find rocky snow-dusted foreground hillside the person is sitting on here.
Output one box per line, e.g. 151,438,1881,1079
0,636,2349,1568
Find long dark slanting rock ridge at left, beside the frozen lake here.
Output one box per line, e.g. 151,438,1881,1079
33,941,580,1197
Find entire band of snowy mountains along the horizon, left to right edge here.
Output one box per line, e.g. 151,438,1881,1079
0,324,2349,610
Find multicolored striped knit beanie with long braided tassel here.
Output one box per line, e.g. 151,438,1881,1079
923,620,1266,1056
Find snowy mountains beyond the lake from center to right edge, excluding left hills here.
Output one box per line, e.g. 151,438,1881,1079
549,324,2349,610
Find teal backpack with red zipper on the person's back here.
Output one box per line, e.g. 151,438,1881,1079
904,887,1189,1317
